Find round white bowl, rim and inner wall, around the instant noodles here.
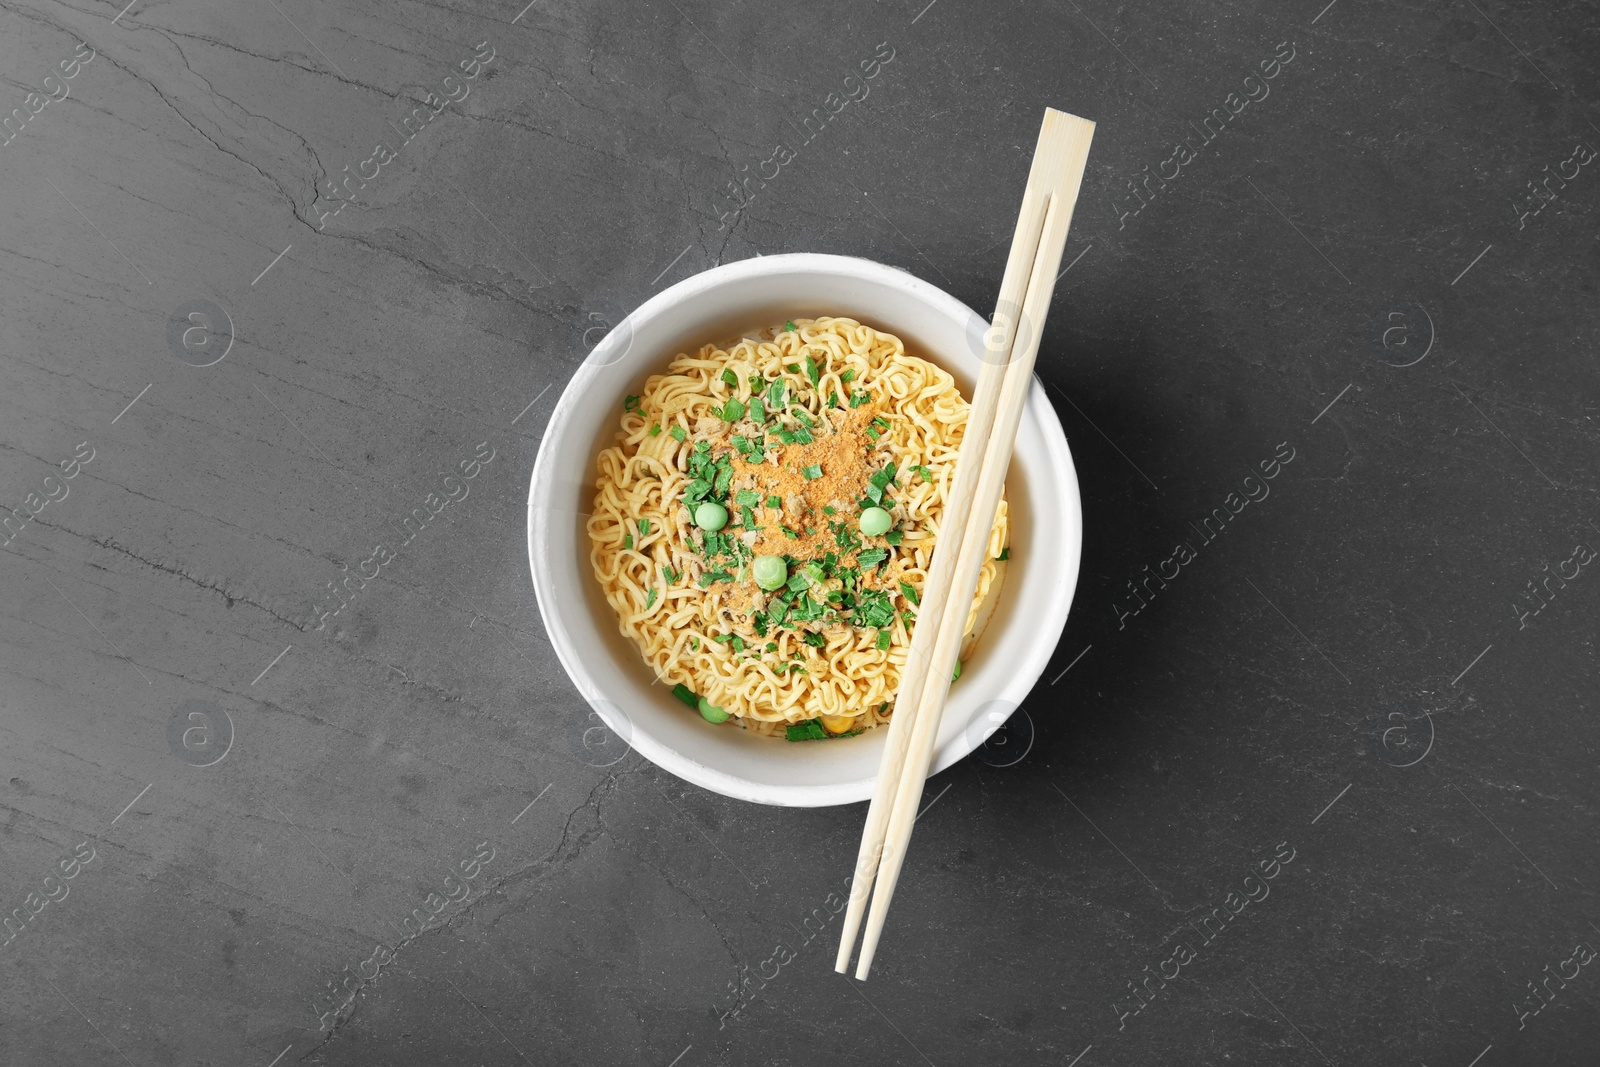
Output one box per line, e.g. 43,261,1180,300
528,253,1083,808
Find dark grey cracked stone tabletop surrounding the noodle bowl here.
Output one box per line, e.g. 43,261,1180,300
0,0,1600,1067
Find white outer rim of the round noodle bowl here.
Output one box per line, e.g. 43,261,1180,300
526,253,1083,808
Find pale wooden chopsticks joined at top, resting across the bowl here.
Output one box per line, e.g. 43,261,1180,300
834,107,1094,979
